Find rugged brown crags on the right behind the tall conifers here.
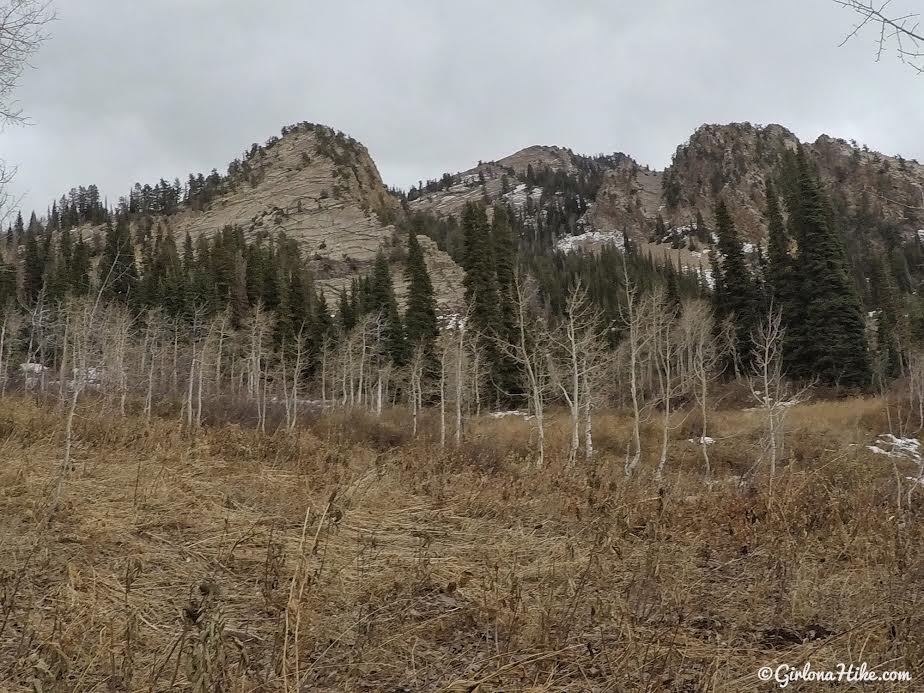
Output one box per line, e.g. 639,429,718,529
591,123,924,242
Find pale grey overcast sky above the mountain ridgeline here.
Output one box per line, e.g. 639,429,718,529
0,0,924,215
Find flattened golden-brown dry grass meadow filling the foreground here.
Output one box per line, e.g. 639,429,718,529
0,398,924,692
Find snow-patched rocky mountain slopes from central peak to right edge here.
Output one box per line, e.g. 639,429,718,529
408,123,924,276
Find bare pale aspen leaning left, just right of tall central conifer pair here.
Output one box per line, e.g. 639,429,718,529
498,273,552,469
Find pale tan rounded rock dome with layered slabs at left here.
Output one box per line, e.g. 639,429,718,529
154,125,399,279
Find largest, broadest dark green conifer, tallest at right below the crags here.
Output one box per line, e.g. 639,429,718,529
787,149,870,387
